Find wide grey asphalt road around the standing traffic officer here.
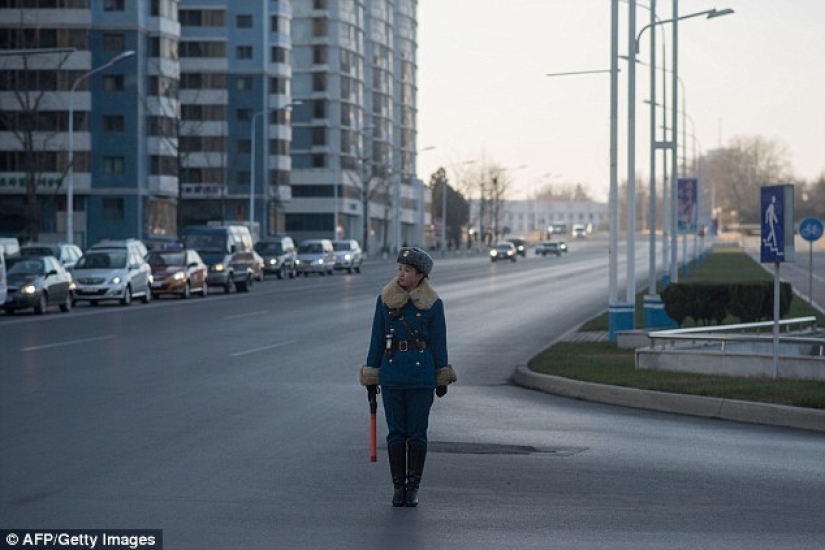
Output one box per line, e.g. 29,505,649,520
0,242,825,550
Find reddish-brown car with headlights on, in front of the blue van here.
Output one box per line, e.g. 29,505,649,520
146,248,209,298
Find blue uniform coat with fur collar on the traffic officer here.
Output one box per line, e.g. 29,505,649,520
366,278,449,390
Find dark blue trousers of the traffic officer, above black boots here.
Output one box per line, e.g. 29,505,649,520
381,388,433,447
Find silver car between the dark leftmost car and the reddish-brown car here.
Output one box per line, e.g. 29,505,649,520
72,247,152,305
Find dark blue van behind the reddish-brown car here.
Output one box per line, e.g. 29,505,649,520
183,225,255,294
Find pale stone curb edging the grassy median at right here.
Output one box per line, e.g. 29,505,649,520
513,365,825,433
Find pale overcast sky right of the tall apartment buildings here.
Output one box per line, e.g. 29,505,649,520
418,0,825,200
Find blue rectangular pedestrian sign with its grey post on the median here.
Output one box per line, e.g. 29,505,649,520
759,185,794,378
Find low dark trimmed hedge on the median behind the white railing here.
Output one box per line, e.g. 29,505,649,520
661,281,793,327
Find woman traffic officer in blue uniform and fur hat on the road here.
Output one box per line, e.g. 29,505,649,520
360,247,457,507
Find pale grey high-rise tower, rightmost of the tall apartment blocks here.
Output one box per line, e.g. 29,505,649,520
286,0,429,251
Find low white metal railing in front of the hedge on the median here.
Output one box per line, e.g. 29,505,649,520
648,316,825,358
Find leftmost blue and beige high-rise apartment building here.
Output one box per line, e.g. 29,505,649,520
0,0,179,245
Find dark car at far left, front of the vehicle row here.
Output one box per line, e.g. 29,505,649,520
3,256,74,314
